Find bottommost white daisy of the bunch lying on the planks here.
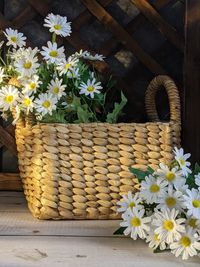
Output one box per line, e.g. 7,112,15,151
170,229,200,260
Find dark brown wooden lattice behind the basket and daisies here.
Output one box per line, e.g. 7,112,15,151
0,0,185,193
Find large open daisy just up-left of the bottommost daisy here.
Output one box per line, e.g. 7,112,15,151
152,209,185,244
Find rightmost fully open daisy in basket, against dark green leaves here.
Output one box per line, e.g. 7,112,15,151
79,77,103,98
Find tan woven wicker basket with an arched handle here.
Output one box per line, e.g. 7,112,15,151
16,76,181,219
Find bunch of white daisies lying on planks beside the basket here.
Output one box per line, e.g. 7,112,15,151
116,148,200,260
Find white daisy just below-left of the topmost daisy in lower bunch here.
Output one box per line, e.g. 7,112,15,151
156,163,186,191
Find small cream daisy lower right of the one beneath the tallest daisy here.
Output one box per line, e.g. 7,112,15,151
57,57,78,75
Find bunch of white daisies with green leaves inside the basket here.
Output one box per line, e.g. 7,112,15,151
0,14,127,123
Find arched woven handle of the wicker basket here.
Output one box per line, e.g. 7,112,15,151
145,75,181,123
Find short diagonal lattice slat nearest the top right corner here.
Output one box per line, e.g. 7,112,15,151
131,0,184,52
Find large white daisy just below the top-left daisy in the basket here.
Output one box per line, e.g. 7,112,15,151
14,48,40,77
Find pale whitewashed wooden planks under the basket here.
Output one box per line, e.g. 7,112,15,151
0,192,200,267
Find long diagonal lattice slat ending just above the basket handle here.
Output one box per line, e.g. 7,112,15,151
81,0,167,75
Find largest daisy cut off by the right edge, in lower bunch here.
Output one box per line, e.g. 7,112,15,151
183,188,200,219
